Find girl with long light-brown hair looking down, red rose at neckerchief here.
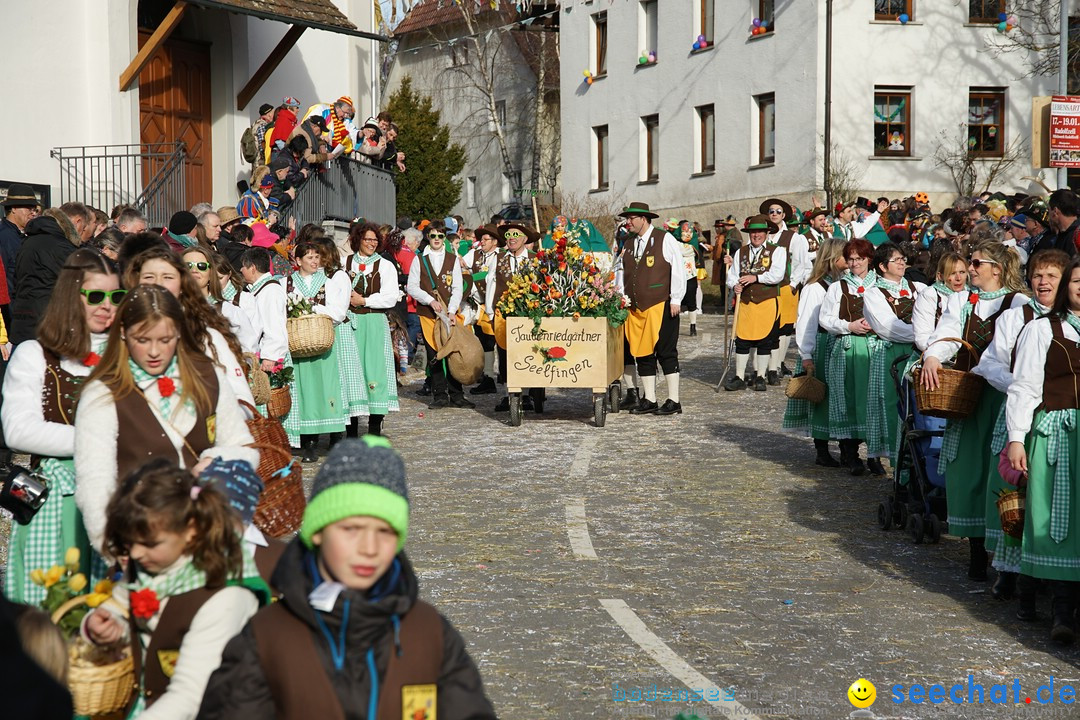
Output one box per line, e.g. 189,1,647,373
75,285,259,548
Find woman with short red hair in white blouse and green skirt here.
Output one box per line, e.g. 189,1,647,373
819,239,877,475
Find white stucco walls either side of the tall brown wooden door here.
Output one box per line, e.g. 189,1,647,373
0,0,377,212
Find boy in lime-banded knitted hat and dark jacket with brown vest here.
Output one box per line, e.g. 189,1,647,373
199,435,496,720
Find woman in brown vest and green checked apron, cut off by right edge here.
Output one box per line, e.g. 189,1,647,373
1005,256,1080,644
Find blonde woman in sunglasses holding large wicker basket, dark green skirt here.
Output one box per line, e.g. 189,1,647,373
919,242,1027,580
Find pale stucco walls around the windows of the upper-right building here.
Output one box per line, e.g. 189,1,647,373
561,0,1056,220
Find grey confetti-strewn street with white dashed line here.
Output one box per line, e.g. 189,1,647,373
388,315,1080,719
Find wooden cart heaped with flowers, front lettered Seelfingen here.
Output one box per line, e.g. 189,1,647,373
498,231,629,427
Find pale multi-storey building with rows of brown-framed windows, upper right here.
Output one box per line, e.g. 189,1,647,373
561,0,1056,223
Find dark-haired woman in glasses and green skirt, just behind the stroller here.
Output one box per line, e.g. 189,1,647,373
863,243,926,475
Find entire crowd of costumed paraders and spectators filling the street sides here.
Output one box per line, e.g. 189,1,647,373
0,90,1080,719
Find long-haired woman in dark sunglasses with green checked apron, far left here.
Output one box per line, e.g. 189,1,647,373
3,248,124,603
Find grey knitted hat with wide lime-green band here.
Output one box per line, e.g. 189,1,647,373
300,435,408,552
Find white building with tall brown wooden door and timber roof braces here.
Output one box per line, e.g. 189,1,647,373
0,0,379,213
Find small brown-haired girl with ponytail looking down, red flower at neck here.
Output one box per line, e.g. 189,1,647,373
83,460,268,720
